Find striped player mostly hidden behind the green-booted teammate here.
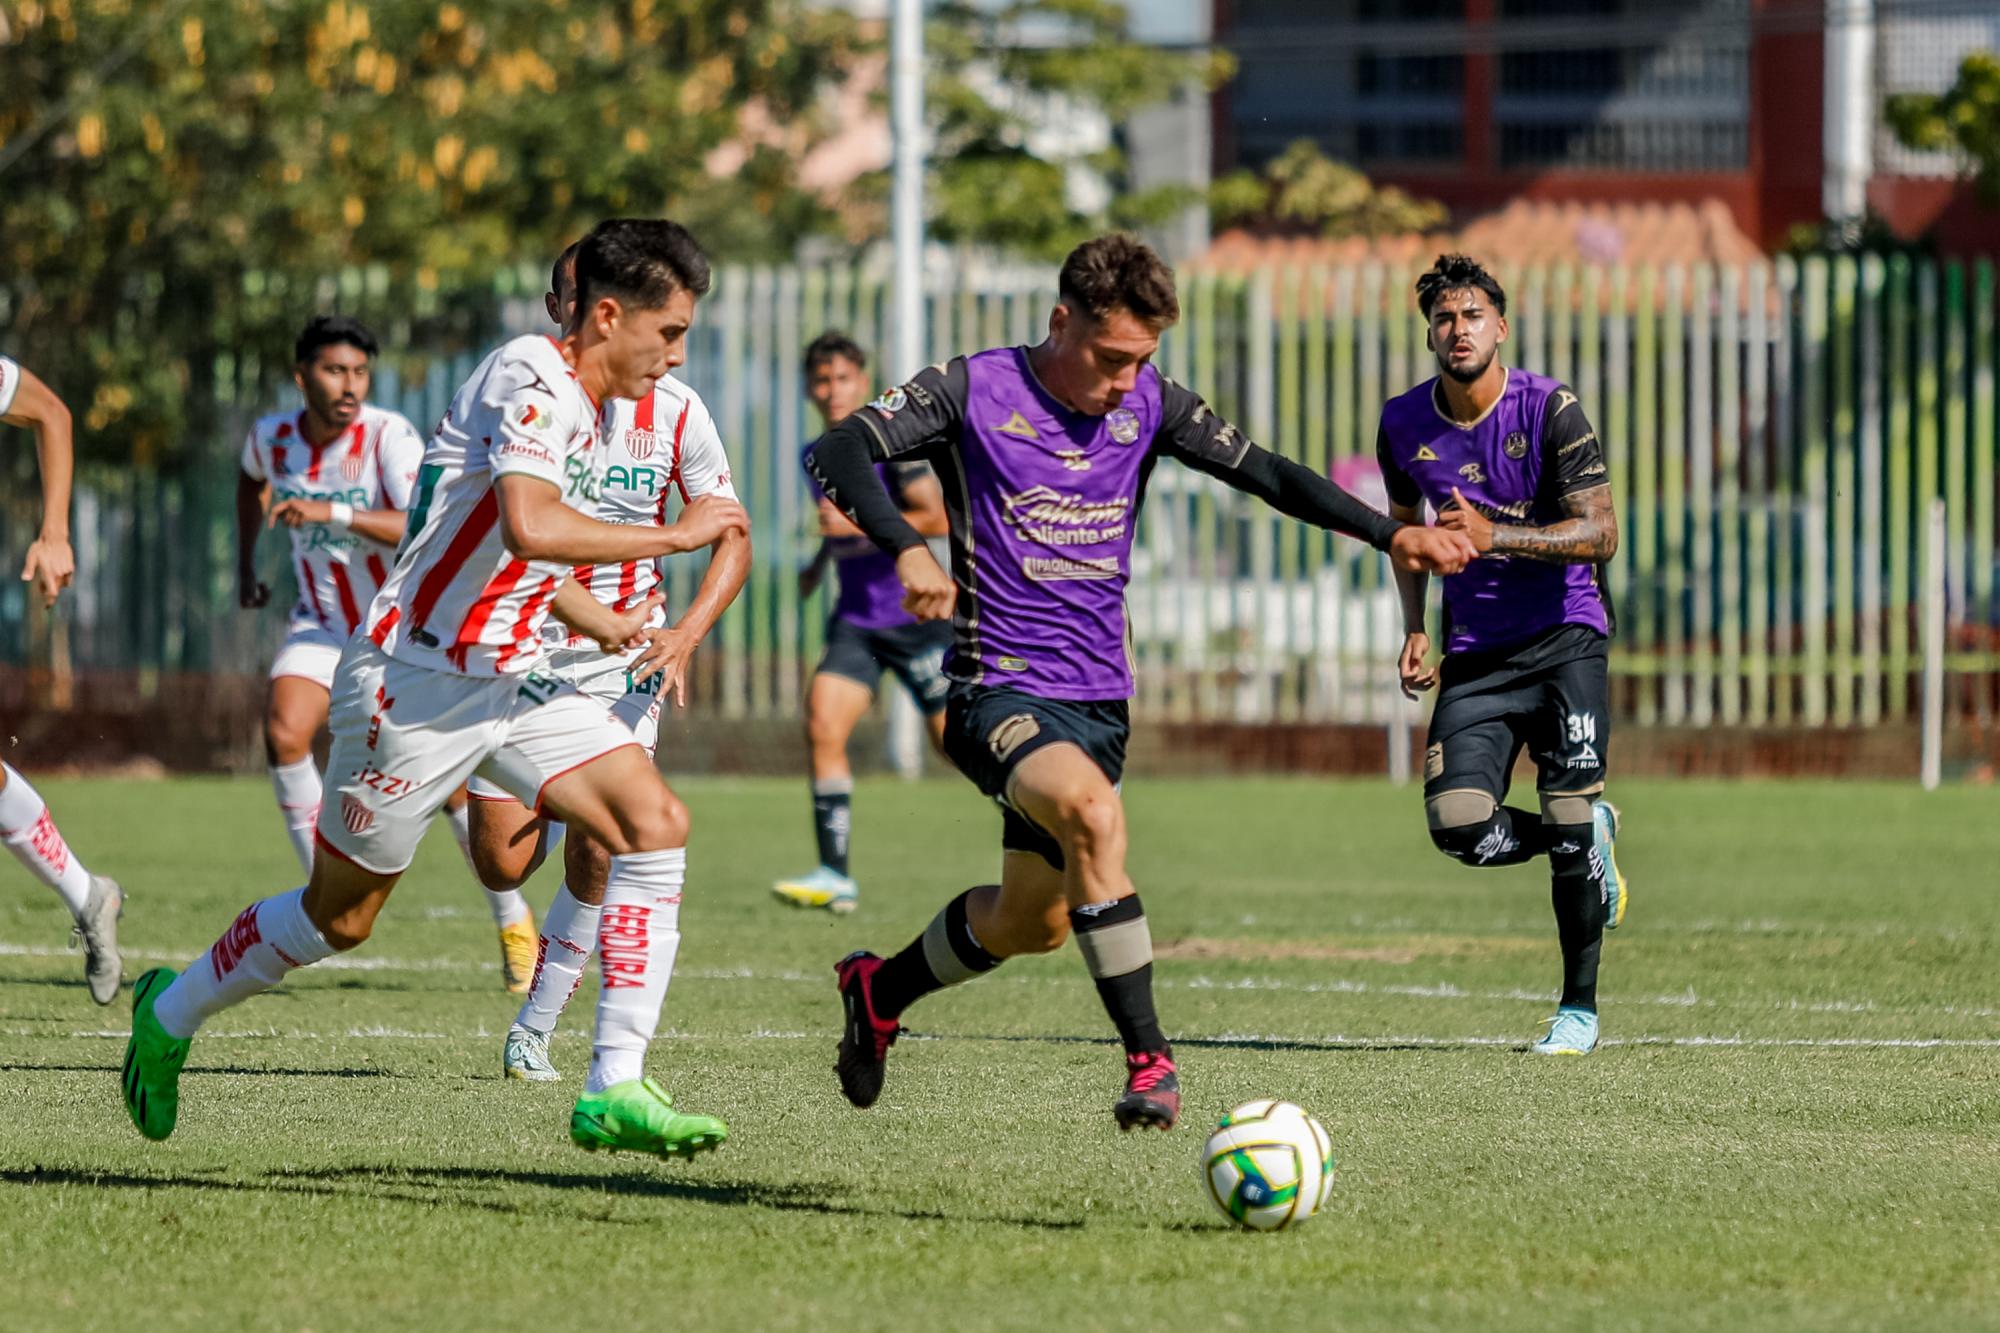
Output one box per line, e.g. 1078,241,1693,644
470,242,750,1083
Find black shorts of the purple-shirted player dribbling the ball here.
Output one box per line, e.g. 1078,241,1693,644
944,685,1132,871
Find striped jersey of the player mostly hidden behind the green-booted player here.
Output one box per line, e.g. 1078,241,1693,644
548,376,736,644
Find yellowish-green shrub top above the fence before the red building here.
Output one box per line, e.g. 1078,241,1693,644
1208,138,1450,236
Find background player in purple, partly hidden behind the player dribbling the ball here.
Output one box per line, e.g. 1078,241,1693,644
772,332,952,913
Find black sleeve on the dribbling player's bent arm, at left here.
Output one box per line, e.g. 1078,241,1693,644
806,356,970,554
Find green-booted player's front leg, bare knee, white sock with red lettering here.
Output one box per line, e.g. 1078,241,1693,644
542,745,728,1157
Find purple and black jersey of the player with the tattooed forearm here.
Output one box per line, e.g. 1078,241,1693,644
1376,366,1610,652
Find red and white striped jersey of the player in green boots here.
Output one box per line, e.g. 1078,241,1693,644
368,334,604,677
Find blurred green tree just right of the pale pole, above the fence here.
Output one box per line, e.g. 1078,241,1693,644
876,0,1234,258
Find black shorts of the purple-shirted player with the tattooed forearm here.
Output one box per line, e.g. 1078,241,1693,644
1424,624,1612,803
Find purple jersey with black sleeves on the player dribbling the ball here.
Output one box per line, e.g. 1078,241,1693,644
808,348,1398,701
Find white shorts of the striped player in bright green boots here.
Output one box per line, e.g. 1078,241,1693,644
318,634,638,875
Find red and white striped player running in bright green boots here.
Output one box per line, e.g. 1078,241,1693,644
122,218,748,1155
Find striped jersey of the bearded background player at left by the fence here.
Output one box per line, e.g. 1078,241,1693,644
242,402,424,638
